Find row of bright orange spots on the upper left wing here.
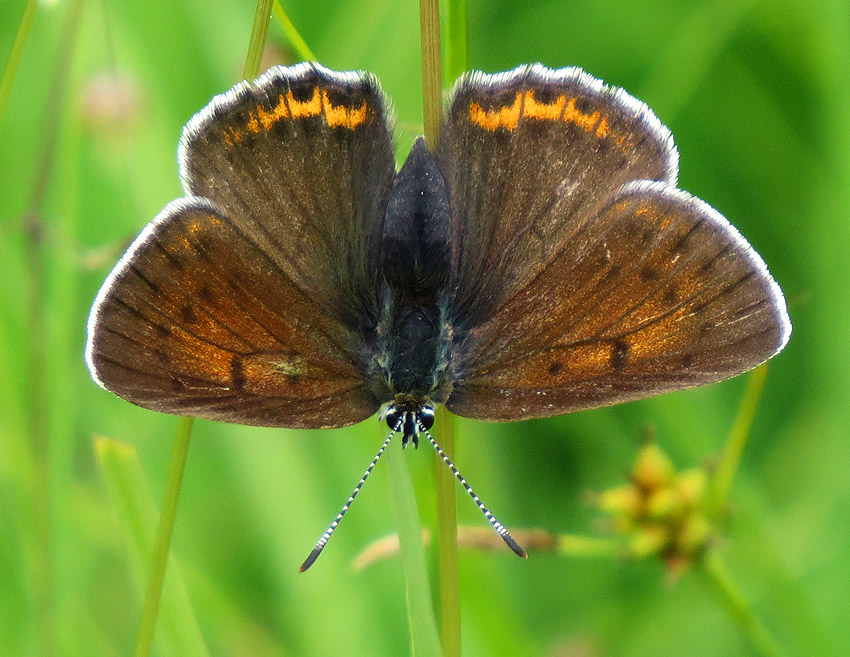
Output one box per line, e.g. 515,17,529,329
222,87,369,146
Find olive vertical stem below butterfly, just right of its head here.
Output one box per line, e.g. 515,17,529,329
433,406,461,657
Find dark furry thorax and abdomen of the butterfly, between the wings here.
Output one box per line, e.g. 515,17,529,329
378,139,451,411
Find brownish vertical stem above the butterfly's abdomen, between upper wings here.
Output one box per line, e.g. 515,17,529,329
419,0,443,151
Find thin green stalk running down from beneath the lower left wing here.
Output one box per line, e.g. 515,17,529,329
136,417,194,657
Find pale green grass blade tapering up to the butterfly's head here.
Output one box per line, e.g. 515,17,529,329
384,440,441,657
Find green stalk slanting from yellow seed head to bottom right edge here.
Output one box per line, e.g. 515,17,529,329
696,548,785,657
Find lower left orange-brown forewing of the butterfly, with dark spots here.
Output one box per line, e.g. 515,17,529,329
88,198,378,427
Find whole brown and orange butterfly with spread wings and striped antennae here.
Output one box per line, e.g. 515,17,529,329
86,64,791,569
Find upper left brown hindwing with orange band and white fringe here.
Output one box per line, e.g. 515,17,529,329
180,64,395,324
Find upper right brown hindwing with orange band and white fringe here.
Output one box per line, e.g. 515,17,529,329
437,65,677,327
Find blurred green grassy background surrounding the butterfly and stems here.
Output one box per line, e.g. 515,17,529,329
0,0,850,657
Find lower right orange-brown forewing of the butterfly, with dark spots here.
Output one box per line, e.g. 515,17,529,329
447,182,790,420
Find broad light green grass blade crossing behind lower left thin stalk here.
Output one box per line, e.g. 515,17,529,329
95,430,209,657
